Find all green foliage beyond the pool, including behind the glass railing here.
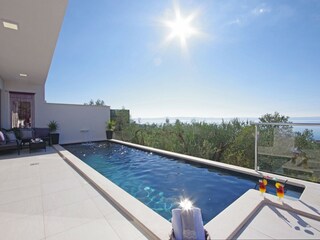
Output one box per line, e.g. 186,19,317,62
115,112,320,180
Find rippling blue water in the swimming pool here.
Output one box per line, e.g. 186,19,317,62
64,142,302,224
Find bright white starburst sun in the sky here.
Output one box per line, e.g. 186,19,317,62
165,8,197,48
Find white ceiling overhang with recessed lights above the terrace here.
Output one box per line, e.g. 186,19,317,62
0,0,68,84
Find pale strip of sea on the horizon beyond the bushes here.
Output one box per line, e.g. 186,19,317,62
133,116,320,141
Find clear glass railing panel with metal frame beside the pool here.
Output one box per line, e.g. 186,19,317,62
256,123,320,182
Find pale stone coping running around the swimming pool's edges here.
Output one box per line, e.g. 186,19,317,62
55,139,320,239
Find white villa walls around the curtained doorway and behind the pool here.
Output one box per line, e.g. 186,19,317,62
0,79,110,144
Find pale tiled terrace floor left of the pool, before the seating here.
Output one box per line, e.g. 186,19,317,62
0,148,146,240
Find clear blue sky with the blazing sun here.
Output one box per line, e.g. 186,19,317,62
46,0,320,118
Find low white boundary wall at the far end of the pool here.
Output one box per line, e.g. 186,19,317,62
38,103,110,144
